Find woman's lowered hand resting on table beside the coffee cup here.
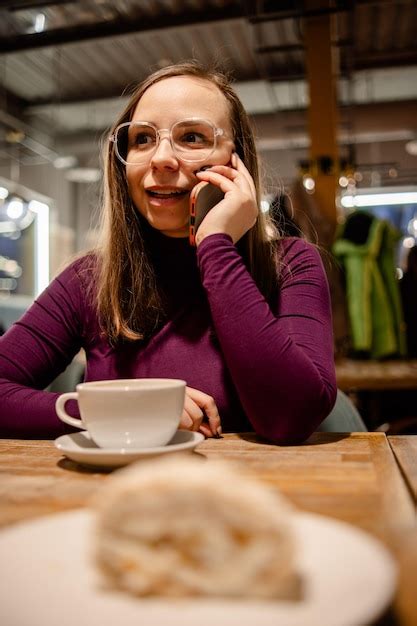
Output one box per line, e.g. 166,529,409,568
180,387,222,437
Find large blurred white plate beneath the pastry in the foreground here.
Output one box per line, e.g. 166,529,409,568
0,510,396,626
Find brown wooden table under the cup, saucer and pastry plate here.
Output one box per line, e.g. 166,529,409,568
0,433,417,626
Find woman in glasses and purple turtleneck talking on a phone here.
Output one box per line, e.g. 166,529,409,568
0,62,336,443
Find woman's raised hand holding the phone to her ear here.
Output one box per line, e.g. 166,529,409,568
196,153,259,246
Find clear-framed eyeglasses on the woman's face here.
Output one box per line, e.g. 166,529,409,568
109,117,226,165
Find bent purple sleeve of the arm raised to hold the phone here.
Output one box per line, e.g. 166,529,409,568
197,234,336,443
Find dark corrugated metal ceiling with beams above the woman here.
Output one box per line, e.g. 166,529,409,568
0,0,417,184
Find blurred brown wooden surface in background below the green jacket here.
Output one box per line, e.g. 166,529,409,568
336,359,417,391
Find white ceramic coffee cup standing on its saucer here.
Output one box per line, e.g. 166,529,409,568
55,378,186,449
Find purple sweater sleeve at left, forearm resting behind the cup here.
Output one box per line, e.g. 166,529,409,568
0,262,85,437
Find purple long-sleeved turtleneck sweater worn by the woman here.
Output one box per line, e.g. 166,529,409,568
0,231,336,443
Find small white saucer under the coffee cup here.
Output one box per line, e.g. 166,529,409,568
55,430,204,467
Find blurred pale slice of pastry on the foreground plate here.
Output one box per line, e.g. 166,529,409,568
95,457,298,599
